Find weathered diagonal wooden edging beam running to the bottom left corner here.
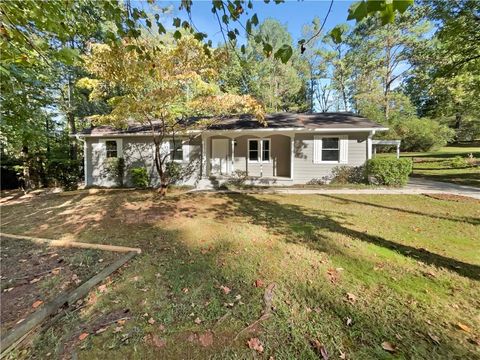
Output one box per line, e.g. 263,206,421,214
0,251,138,358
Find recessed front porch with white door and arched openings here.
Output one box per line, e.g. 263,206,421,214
202,132,294,185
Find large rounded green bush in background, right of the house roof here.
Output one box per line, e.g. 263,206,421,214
394,118,455,151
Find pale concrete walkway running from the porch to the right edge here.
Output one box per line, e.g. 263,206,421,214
266,178,480,199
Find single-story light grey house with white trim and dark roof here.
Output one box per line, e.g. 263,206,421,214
77,112,388,187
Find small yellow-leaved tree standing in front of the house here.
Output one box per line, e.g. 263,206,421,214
81,36,264,194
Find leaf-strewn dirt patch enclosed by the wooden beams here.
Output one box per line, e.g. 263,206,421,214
0,238,118,336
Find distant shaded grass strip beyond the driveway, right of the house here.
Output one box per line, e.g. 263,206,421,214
379,146,480,187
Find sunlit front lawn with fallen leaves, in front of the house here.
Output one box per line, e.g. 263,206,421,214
2,191,480,359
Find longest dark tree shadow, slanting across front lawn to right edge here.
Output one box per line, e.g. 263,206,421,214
224,194,480,280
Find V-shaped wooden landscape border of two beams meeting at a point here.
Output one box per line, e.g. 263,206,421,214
0,233,141,359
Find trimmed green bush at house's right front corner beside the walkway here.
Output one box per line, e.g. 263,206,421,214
367,157,412,186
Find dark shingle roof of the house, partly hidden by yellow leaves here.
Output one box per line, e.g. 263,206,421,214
82,112,384,135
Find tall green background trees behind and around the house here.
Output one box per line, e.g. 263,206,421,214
0,0,480,188
